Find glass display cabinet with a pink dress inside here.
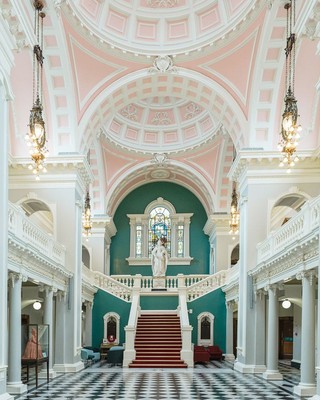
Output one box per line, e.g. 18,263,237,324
22,324,49,387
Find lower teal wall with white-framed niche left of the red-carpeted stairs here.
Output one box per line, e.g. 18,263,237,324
92,290,131,347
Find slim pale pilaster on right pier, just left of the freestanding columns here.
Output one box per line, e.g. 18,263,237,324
254,290,266,373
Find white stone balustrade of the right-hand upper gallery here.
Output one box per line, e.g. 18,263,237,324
257,196,320,264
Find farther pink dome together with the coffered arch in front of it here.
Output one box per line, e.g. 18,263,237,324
80,68,247,153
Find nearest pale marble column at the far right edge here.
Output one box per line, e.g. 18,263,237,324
294,271,319,396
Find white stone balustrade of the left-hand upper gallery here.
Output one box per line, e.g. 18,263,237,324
8,202,66,267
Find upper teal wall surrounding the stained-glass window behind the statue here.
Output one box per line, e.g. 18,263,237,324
110,182,210,276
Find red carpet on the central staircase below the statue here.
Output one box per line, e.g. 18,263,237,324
129,314,187,368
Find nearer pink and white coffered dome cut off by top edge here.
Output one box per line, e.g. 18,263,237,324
69,0,260,55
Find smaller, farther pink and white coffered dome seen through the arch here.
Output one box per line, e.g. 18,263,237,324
105,96,218,152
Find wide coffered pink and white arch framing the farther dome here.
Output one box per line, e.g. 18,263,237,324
79,68,248,153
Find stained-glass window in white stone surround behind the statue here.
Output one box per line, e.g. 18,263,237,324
127,197,193,265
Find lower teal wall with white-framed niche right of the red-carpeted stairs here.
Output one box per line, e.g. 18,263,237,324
188,289,226,352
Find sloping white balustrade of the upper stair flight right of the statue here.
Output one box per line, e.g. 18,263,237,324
187,270,229,301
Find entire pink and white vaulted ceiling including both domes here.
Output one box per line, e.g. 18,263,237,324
6,0,320,219
